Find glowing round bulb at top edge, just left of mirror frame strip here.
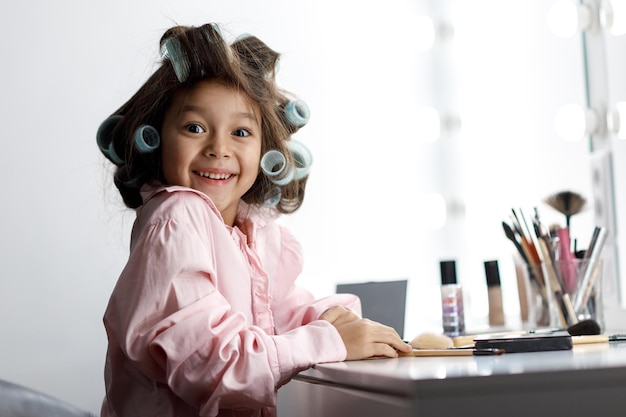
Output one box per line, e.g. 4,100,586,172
547,0,594,38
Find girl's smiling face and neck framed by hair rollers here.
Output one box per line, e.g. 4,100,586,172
161,81,262,226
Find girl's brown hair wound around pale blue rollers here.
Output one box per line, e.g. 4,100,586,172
98,24,307,213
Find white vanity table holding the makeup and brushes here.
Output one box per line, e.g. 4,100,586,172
278,342,626,417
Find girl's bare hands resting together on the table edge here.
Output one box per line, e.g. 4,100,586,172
320,306,413,360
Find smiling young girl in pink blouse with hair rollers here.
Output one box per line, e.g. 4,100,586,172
97,24,410,417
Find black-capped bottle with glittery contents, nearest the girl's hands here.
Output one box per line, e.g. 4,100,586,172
439,261,465,337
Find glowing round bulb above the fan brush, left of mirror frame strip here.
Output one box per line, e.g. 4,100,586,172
554,103,598,142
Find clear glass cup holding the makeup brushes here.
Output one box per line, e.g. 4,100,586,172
523,258,604,329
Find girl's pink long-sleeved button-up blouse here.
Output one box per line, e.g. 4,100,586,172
102,187,360,417
